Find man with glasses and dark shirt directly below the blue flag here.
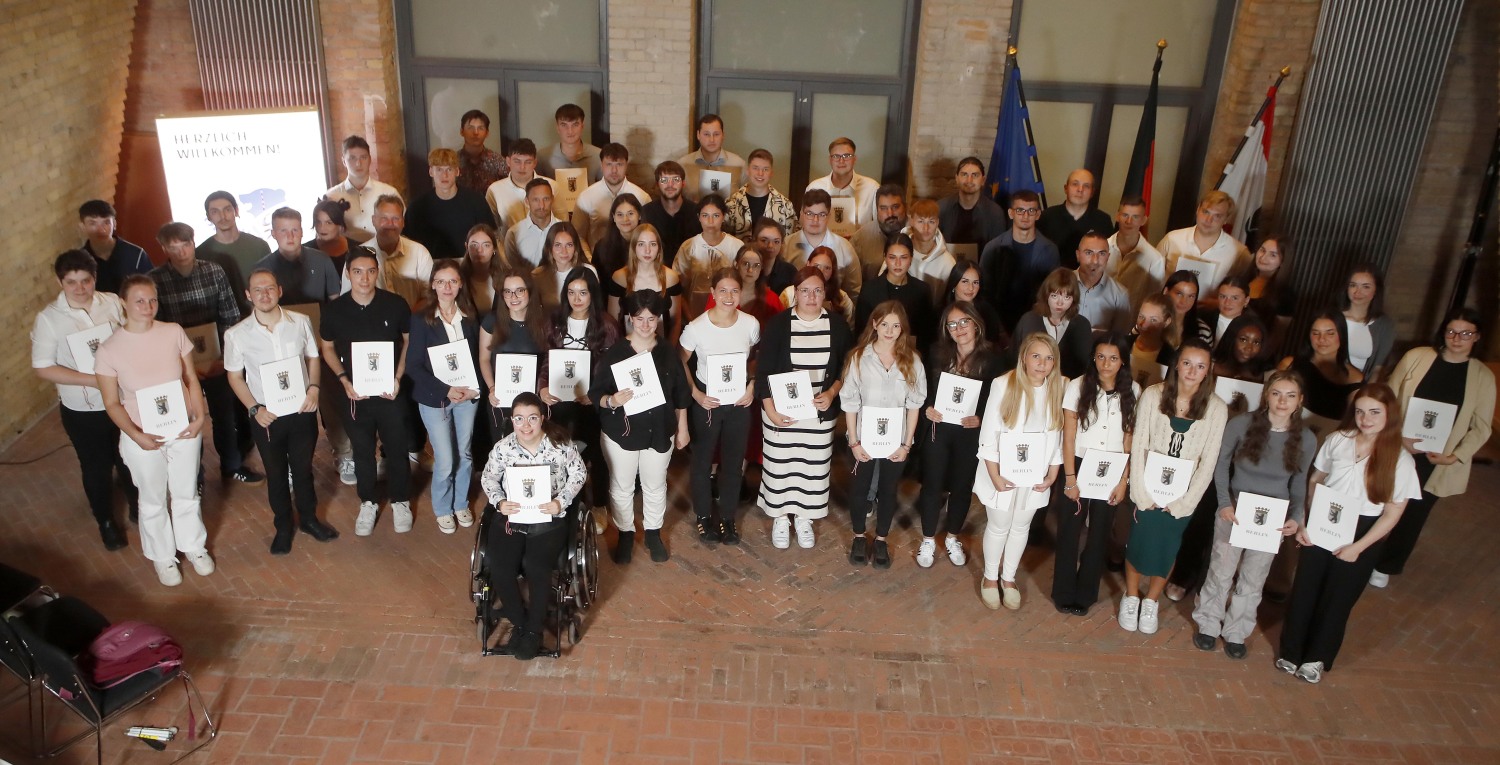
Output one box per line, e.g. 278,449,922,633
980,189,1061,332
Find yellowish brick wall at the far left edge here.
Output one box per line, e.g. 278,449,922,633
0,0,135,444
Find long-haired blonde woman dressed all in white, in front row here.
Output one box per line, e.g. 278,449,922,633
974,333,1071,611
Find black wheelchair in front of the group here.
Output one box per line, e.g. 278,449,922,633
470,501,599,659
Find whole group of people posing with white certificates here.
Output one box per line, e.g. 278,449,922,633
33,105,1496,666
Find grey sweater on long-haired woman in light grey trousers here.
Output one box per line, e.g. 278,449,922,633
1214,413,1317,525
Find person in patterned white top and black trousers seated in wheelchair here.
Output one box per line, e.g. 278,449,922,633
480,393,588,662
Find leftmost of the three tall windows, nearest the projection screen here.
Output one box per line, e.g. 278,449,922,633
396,0,609,189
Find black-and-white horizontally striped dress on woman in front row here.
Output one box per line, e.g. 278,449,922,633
759,311,834,521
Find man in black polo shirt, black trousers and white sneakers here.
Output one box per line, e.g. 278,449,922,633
318,249,411,537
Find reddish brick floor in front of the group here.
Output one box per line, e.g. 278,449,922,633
0,416,1500,765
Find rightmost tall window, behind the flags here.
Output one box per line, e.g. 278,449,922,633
1011,0,1235,242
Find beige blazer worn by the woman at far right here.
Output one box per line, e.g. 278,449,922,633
1389,345,1496,497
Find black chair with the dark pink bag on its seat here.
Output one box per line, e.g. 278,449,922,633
12,620,218,765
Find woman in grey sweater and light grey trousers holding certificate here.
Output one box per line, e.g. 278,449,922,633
1193,371,1317,659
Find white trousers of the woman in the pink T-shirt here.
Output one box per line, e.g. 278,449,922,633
120,434,209,563
